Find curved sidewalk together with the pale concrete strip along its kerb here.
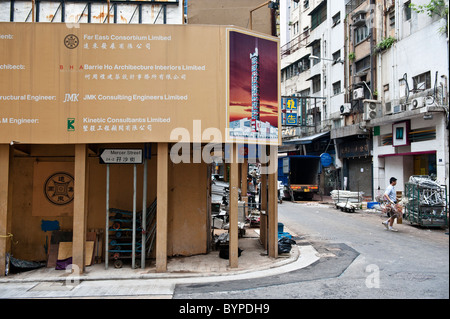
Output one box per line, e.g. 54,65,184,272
0,230,320,299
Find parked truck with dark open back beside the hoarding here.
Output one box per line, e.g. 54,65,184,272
278,155,321,200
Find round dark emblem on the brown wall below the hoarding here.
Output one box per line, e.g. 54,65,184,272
44,172,74,205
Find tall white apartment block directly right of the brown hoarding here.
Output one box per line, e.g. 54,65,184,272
280,0,345,195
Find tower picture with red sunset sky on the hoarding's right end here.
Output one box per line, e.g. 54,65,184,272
227,30,281,144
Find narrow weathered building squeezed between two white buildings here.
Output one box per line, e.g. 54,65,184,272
331,0,382,198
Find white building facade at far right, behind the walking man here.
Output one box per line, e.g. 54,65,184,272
369,0,449,191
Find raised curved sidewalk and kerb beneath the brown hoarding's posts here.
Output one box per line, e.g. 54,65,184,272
0,232,319,284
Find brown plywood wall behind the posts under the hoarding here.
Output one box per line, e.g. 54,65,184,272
8,145,207,261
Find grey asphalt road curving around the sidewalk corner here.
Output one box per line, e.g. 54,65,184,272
173,202,449,299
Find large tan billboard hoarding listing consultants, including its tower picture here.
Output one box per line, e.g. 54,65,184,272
0,23,281,144
